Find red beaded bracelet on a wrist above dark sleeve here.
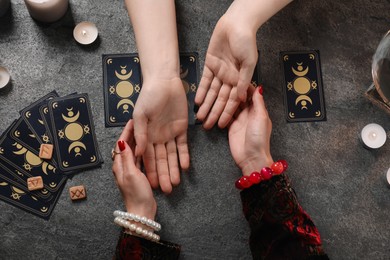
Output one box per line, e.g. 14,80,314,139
236,160,288,190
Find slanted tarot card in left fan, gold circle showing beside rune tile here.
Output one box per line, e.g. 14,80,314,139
0,127,66,192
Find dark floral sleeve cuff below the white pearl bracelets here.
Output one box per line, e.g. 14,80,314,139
113,231,180,260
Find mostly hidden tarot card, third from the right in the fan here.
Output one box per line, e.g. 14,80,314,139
20,91,58,144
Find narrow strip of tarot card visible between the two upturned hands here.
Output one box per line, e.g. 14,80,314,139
180,52,199,125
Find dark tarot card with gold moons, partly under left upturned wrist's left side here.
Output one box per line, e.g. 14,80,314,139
103,54,142,127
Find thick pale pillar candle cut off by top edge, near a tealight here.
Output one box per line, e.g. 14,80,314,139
24,0,68,23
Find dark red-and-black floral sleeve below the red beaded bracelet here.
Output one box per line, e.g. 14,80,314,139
241,174,329,259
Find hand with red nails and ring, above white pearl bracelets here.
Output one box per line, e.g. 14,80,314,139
112,120,157,220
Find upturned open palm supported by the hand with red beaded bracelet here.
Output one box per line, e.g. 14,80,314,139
195,14,258,129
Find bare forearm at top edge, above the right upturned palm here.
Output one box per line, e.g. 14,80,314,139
226,0,292,32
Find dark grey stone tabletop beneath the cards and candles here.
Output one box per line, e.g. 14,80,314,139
0,0,390,259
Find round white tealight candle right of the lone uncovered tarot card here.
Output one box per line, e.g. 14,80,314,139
361,123,387,149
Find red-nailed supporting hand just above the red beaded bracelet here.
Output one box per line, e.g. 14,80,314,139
229,87,273,176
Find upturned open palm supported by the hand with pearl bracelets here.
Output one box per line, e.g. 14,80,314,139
133,78,190,193
